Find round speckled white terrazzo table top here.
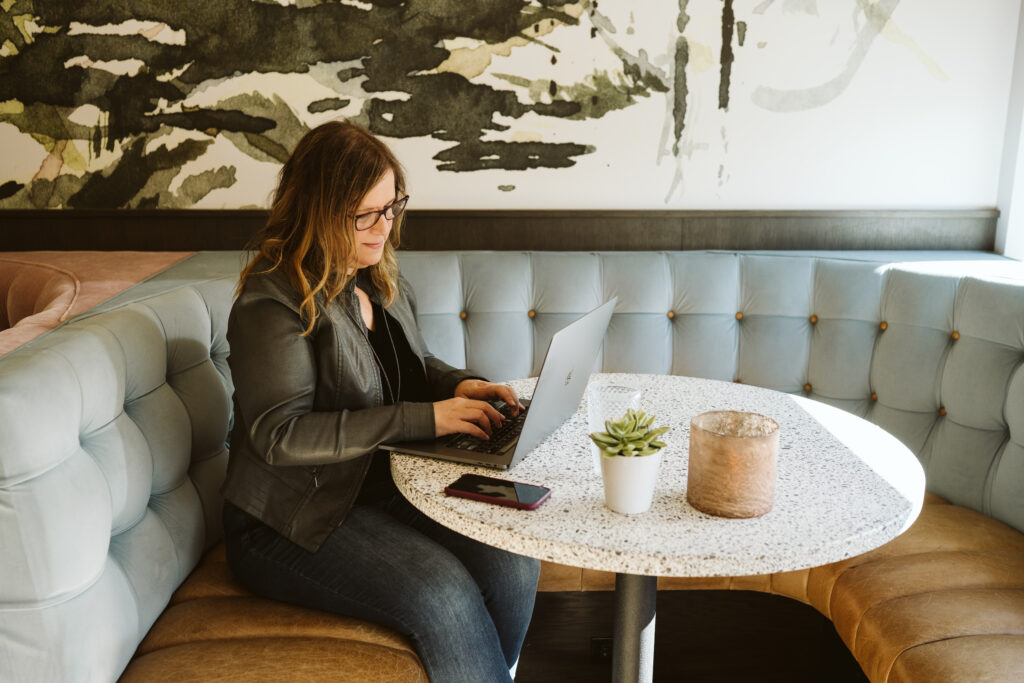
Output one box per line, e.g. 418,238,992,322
391,374,925,577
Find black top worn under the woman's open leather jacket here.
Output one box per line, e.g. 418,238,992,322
356,301,430,503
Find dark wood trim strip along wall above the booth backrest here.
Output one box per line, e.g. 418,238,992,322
0,209,998,251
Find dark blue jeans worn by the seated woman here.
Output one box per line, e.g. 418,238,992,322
224,495,540,683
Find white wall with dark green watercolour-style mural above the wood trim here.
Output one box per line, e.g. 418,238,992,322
0,0,1020,209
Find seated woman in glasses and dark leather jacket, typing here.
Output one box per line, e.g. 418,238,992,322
223,122,540,683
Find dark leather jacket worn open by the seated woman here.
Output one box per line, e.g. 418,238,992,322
222,262,475,551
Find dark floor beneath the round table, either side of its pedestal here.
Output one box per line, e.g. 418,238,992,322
516,591,867,683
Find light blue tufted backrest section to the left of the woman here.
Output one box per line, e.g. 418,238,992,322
0,275,234,681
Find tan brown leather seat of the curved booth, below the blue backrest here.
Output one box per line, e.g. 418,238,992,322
121,495,1024,683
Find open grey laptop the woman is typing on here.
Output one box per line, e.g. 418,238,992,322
381,297,618,470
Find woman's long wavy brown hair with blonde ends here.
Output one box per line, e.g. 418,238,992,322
237,121,406,336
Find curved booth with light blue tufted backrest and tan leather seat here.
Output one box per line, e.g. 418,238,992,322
0,252,1024,681
